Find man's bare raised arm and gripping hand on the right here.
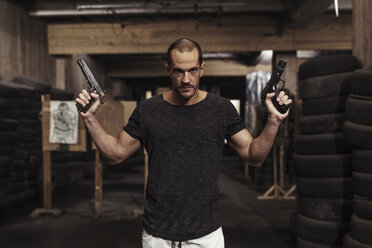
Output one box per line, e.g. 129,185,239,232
229,91,292,167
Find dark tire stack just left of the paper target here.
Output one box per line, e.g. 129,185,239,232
9,77,51,206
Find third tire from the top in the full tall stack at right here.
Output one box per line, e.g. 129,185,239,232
302,95,348,115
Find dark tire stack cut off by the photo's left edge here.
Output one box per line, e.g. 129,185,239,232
0,82,19,209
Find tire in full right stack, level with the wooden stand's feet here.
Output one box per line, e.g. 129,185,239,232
296,177,353,199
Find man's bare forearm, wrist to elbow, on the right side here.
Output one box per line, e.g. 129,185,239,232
247,120,280,166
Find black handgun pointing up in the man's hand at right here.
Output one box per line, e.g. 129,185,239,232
261,60,290,114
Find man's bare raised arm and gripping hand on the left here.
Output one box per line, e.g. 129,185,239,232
76,90,141,164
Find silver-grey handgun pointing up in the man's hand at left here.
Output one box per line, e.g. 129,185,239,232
76,58,105,113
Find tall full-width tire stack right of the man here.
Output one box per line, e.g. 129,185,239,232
293,55,360,248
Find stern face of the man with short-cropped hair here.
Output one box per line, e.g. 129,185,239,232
167,48,204,99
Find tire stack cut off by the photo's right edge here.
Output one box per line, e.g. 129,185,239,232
344,69,372,248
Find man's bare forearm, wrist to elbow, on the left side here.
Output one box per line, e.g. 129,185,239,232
84,116,123,164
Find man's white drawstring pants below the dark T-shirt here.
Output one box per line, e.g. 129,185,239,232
142,227,225,248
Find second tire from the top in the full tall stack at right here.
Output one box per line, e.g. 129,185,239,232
298,72,352,99
